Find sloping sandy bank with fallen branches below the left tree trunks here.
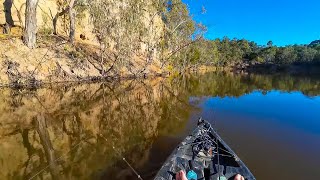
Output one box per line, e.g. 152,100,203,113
0,35,167,87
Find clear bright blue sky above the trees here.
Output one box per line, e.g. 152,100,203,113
182,0,320,46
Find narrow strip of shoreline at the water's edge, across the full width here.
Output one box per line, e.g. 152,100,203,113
0,64,320,89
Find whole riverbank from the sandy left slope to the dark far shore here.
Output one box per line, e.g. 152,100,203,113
0,35,320,88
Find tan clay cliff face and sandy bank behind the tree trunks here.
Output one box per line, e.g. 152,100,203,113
0,0,165,86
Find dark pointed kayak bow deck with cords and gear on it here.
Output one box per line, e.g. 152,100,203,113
155,120,255,180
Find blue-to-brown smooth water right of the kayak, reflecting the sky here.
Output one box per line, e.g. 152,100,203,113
198,90,320,180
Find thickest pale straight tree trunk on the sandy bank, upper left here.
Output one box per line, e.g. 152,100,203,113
23,0,39,48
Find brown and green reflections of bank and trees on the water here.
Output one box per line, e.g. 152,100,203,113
0,73,320,179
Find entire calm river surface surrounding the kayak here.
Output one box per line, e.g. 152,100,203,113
0,73,320,180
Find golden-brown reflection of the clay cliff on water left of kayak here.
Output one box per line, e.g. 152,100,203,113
0,79,191,179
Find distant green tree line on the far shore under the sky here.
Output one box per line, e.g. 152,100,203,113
182,37,320,66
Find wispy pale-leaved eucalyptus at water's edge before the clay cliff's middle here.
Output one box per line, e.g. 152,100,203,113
89,0,147,76
